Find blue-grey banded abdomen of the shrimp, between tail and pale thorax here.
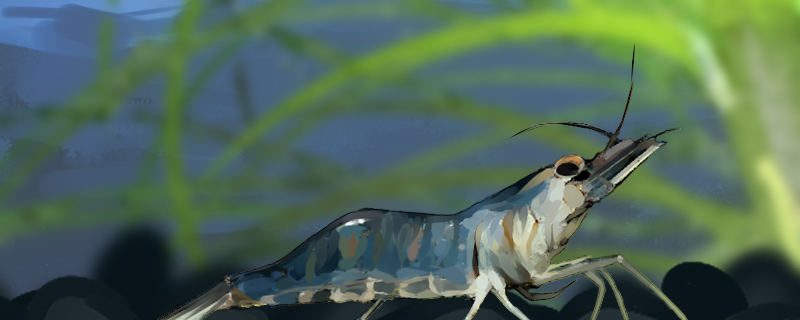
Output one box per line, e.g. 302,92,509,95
225,209,471,305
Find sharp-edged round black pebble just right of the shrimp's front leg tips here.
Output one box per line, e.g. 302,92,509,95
662,262,748,319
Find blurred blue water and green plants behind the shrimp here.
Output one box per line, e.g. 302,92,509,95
0,0,800,316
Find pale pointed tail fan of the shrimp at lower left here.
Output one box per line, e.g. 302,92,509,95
158,280,232,320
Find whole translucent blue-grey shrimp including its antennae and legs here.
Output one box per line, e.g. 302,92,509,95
161,47,686,320
